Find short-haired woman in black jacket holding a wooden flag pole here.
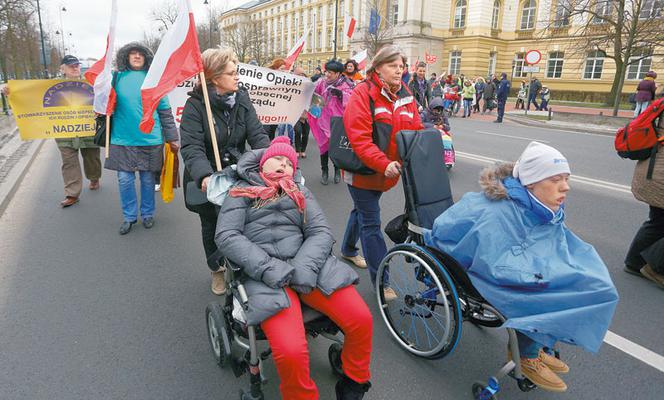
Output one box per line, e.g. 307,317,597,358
180,48,270,295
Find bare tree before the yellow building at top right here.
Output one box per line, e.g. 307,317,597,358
544,0,664,116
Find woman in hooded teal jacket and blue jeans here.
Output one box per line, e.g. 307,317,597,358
104,42,178,235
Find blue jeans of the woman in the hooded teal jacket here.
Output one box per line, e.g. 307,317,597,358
118,171,155,222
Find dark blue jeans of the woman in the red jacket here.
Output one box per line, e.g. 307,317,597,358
341,185,387,285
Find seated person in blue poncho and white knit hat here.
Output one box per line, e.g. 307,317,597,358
424,142,618,392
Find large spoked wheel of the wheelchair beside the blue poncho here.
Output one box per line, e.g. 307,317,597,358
376,244,462,359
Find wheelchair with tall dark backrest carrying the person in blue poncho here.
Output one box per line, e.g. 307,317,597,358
376,129,559,400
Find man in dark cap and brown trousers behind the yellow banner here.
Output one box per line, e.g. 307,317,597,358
2,55,101,208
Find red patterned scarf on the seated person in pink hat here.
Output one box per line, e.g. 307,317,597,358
229,172,305,214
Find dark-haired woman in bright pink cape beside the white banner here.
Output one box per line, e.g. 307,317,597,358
308,60,355,185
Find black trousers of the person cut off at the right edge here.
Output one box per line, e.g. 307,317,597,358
625,206,664,274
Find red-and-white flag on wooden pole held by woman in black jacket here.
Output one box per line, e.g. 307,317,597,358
139,0,203,133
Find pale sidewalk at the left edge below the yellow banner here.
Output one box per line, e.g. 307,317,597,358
0,115,44,215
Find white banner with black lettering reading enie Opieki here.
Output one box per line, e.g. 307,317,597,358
168,64,315,125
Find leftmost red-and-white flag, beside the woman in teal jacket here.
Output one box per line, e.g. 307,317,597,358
84,0,118,115
